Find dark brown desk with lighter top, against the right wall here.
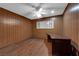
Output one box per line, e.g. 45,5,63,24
47,34,72,56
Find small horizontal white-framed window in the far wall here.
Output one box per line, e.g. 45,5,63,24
36,18,54,29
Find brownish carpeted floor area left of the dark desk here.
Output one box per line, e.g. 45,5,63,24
0,39,48,56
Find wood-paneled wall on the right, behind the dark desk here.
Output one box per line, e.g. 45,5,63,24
63,3,79,49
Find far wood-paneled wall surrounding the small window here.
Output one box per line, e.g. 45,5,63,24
32,16,63,39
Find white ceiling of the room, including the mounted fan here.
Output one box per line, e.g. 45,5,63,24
0,3,67,19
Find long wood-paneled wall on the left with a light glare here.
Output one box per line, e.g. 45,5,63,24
0,8,32,48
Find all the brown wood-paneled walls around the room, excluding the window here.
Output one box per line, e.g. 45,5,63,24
0,3,79,53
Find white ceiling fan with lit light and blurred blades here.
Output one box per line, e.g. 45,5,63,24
27,3,46,17
